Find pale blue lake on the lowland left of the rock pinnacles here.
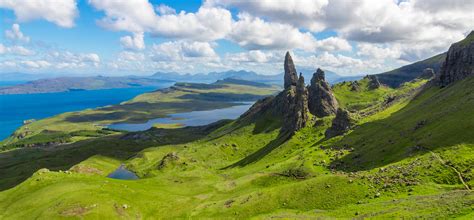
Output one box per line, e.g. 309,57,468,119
108,102,253,131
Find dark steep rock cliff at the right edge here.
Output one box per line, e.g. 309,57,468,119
438,31,474,87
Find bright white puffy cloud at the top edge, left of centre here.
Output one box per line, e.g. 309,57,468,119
89,0,232,41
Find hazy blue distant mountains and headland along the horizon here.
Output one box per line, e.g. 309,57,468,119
0,69,361,94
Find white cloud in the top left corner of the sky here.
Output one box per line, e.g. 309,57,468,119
0,0,78,28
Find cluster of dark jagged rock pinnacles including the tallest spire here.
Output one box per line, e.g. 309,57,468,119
239,52,344,134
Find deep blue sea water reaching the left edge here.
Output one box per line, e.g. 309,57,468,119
0,83,172,140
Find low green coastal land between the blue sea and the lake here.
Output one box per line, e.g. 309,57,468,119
0,82,279,149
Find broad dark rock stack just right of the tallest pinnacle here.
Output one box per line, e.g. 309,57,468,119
308,68,338,117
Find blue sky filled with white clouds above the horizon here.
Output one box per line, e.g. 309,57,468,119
0,0,474,76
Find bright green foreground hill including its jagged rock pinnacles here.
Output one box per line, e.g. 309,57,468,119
0,34,474,219
